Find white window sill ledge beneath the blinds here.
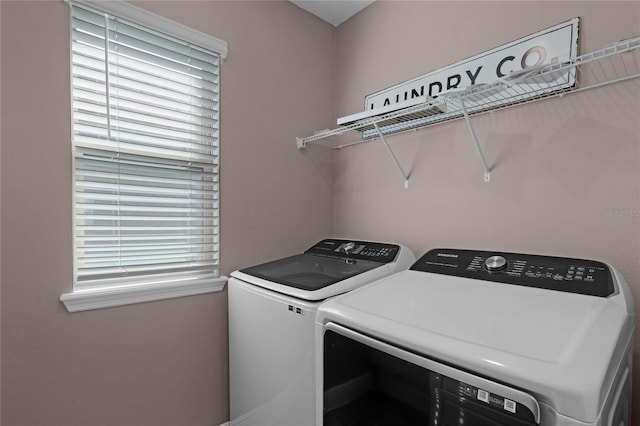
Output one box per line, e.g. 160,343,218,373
60,276,227,312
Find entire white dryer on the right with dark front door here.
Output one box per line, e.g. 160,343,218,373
316,249,635,426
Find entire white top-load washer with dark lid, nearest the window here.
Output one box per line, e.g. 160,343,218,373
228,239,415,426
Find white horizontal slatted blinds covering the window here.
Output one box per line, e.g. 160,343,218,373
71,3,220,290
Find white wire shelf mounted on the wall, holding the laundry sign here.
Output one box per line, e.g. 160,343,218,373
297,37,640,150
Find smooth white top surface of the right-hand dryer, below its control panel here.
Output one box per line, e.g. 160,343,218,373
318,248,634,422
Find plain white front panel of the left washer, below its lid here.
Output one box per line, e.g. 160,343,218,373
229,278,317,426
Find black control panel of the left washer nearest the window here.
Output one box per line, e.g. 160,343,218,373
305,239,400,263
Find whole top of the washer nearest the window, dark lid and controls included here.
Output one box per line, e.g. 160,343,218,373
231,239,415,301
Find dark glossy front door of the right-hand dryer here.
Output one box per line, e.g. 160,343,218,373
318,323,540,426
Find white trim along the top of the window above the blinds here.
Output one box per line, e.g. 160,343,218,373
65,0,228,59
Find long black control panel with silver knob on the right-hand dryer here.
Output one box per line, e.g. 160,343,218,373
411,249,614,297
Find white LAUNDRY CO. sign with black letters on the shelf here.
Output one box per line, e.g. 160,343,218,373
365,18,580,110
